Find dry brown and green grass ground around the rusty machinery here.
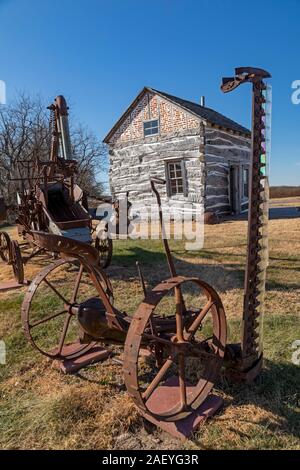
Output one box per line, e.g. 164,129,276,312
0,210,300,449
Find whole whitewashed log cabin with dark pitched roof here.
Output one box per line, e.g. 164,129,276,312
104,87,251,216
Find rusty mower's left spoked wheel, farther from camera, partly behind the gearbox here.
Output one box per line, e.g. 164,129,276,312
22,259,111,359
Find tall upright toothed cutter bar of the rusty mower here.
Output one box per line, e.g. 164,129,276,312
221,67,271,381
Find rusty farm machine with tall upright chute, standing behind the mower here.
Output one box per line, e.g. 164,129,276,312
0,96,112,288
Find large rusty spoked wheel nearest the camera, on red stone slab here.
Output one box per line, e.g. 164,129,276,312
124,277,227,421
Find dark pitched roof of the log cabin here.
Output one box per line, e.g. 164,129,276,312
103,87,251,143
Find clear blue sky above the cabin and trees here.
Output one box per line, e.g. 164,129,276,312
0,0,300,185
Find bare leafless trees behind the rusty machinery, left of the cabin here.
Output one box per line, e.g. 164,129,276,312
0,94,107,207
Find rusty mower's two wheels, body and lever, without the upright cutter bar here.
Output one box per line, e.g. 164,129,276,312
22,178,226,430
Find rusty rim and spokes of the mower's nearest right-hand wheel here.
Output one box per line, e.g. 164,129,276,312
124,277,227,421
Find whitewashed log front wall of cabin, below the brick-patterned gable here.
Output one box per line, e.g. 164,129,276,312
109,129,205,211
